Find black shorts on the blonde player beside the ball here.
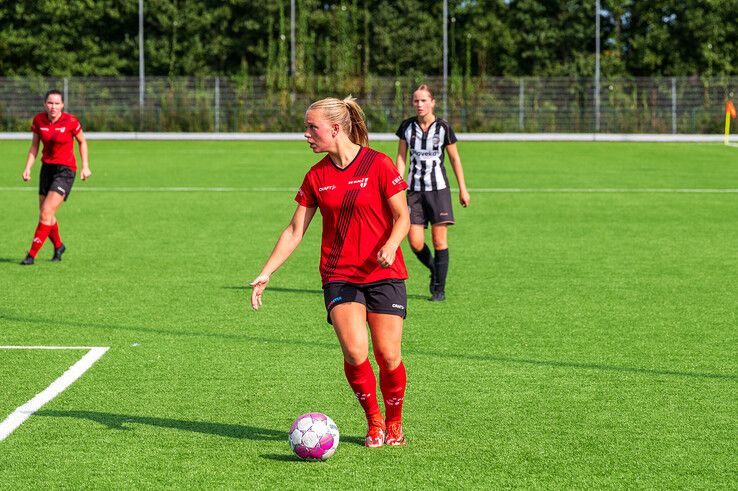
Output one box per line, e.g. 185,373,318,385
323,280,407,324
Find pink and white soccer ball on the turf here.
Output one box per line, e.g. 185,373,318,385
289,413,338,460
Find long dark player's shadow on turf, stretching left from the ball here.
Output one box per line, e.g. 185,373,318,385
35,410,287,442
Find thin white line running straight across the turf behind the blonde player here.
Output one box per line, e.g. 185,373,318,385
0,186,738,194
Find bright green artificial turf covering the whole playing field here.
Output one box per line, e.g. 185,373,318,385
0,141,738,489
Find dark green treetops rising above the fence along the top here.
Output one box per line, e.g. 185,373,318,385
0,0,738,81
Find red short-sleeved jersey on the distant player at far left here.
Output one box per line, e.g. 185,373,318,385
31,112,82,172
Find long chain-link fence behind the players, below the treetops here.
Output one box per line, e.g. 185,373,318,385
0,77,738,133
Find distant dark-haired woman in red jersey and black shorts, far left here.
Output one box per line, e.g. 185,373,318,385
21,90,91,265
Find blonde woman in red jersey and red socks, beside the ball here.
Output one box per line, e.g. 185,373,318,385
251,97,410,447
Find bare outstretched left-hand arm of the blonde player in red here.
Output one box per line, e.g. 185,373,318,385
251,205,317,310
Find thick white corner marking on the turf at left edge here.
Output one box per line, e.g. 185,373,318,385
0,346,110,441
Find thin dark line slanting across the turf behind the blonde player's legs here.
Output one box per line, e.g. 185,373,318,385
0,312,738,380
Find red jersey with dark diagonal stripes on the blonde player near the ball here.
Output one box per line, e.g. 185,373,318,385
295,147,407,285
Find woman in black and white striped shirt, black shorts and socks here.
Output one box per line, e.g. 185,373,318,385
396,84,469,301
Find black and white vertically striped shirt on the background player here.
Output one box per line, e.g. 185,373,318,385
395,117,456,191
